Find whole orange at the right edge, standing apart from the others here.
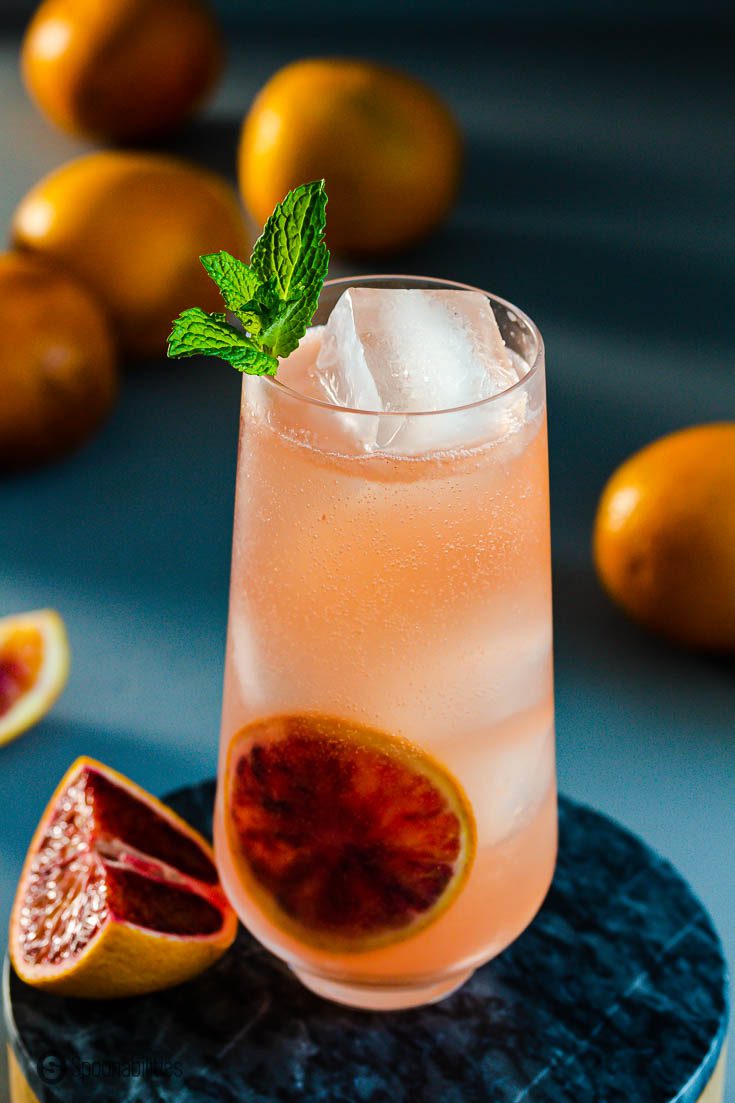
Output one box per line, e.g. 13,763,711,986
594,421,735,652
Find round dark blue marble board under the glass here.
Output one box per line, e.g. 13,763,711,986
6,782,727,1103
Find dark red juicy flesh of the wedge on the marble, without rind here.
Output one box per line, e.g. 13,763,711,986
17,765,226,966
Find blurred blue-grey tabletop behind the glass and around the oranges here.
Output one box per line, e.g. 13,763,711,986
0,17,735,1103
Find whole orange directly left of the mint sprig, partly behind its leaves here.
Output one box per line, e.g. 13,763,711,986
12,152,249,355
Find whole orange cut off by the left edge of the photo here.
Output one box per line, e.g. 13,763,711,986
0,253,117,471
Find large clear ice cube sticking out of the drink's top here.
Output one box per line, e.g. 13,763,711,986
316,288,523,453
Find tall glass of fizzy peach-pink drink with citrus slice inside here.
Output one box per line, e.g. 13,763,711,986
215,277,556,1009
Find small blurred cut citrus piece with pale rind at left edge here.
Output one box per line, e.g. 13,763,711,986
0,609,68,743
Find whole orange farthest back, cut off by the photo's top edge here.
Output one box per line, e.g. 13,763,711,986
21,0,223,141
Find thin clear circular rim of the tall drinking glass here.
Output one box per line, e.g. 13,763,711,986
259,272,544,418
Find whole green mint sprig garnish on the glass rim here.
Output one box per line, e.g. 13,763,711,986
168,180,329,375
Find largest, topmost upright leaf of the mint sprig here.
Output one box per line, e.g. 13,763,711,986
251,180,329,309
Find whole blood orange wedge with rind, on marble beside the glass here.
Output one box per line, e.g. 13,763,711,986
10,758,237,998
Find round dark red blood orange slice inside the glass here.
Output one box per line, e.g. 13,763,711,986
226,716,476,951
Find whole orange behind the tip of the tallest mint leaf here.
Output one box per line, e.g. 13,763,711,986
238,58,461,255
